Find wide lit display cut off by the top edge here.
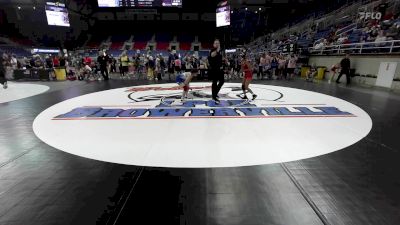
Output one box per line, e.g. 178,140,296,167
97,0,182,8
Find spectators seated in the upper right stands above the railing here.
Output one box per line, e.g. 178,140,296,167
246,1,400,55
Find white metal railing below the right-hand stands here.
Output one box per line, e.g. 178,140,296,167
308,40,400,55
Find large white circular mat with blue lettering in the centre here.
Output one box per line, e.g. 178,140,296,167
33,83,372,168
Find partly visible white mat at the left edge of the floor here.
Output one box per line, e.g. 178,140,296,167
0,82,50,103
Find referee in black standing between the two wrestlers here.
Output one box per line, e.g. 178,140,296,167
208,39,225,104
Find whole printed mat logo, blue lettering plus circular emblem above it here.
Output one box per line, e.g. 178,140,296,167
53,85,355,120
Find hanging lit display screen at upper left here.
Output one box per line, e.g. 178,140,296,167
46,2,70,27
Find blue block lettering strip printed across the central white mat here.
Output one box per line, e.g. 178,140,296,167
53,100,354,120
